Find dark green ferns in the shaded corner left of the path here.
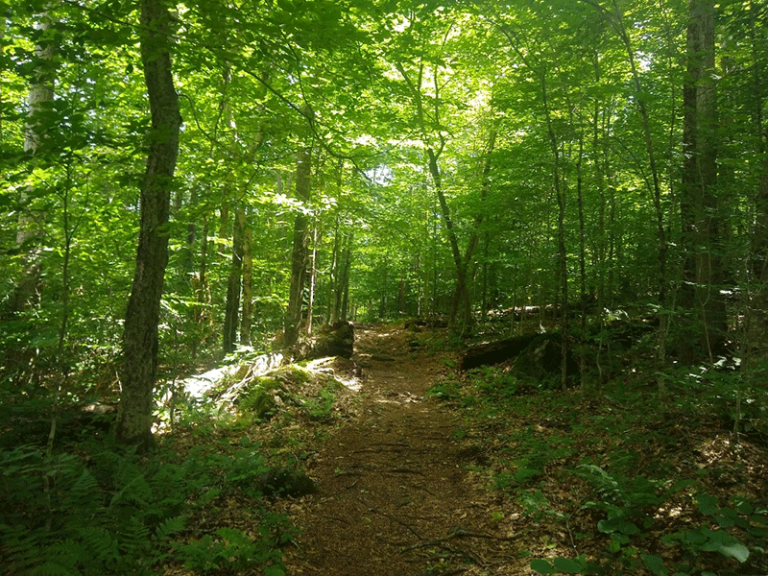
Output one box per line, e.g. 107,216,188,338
0,432,293,576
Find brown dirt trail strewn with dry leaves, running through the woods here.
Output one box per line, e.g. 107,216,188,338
286,327,530,576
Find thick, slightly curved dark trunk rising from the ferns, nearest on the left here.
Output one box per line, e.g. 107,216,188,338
116,0,181,452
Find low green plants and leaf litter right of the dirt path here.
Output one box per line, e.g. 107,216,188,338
431,360,768,576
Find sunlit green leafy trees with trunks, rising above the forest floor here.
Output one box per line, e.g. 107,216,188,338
0,0,768,443
